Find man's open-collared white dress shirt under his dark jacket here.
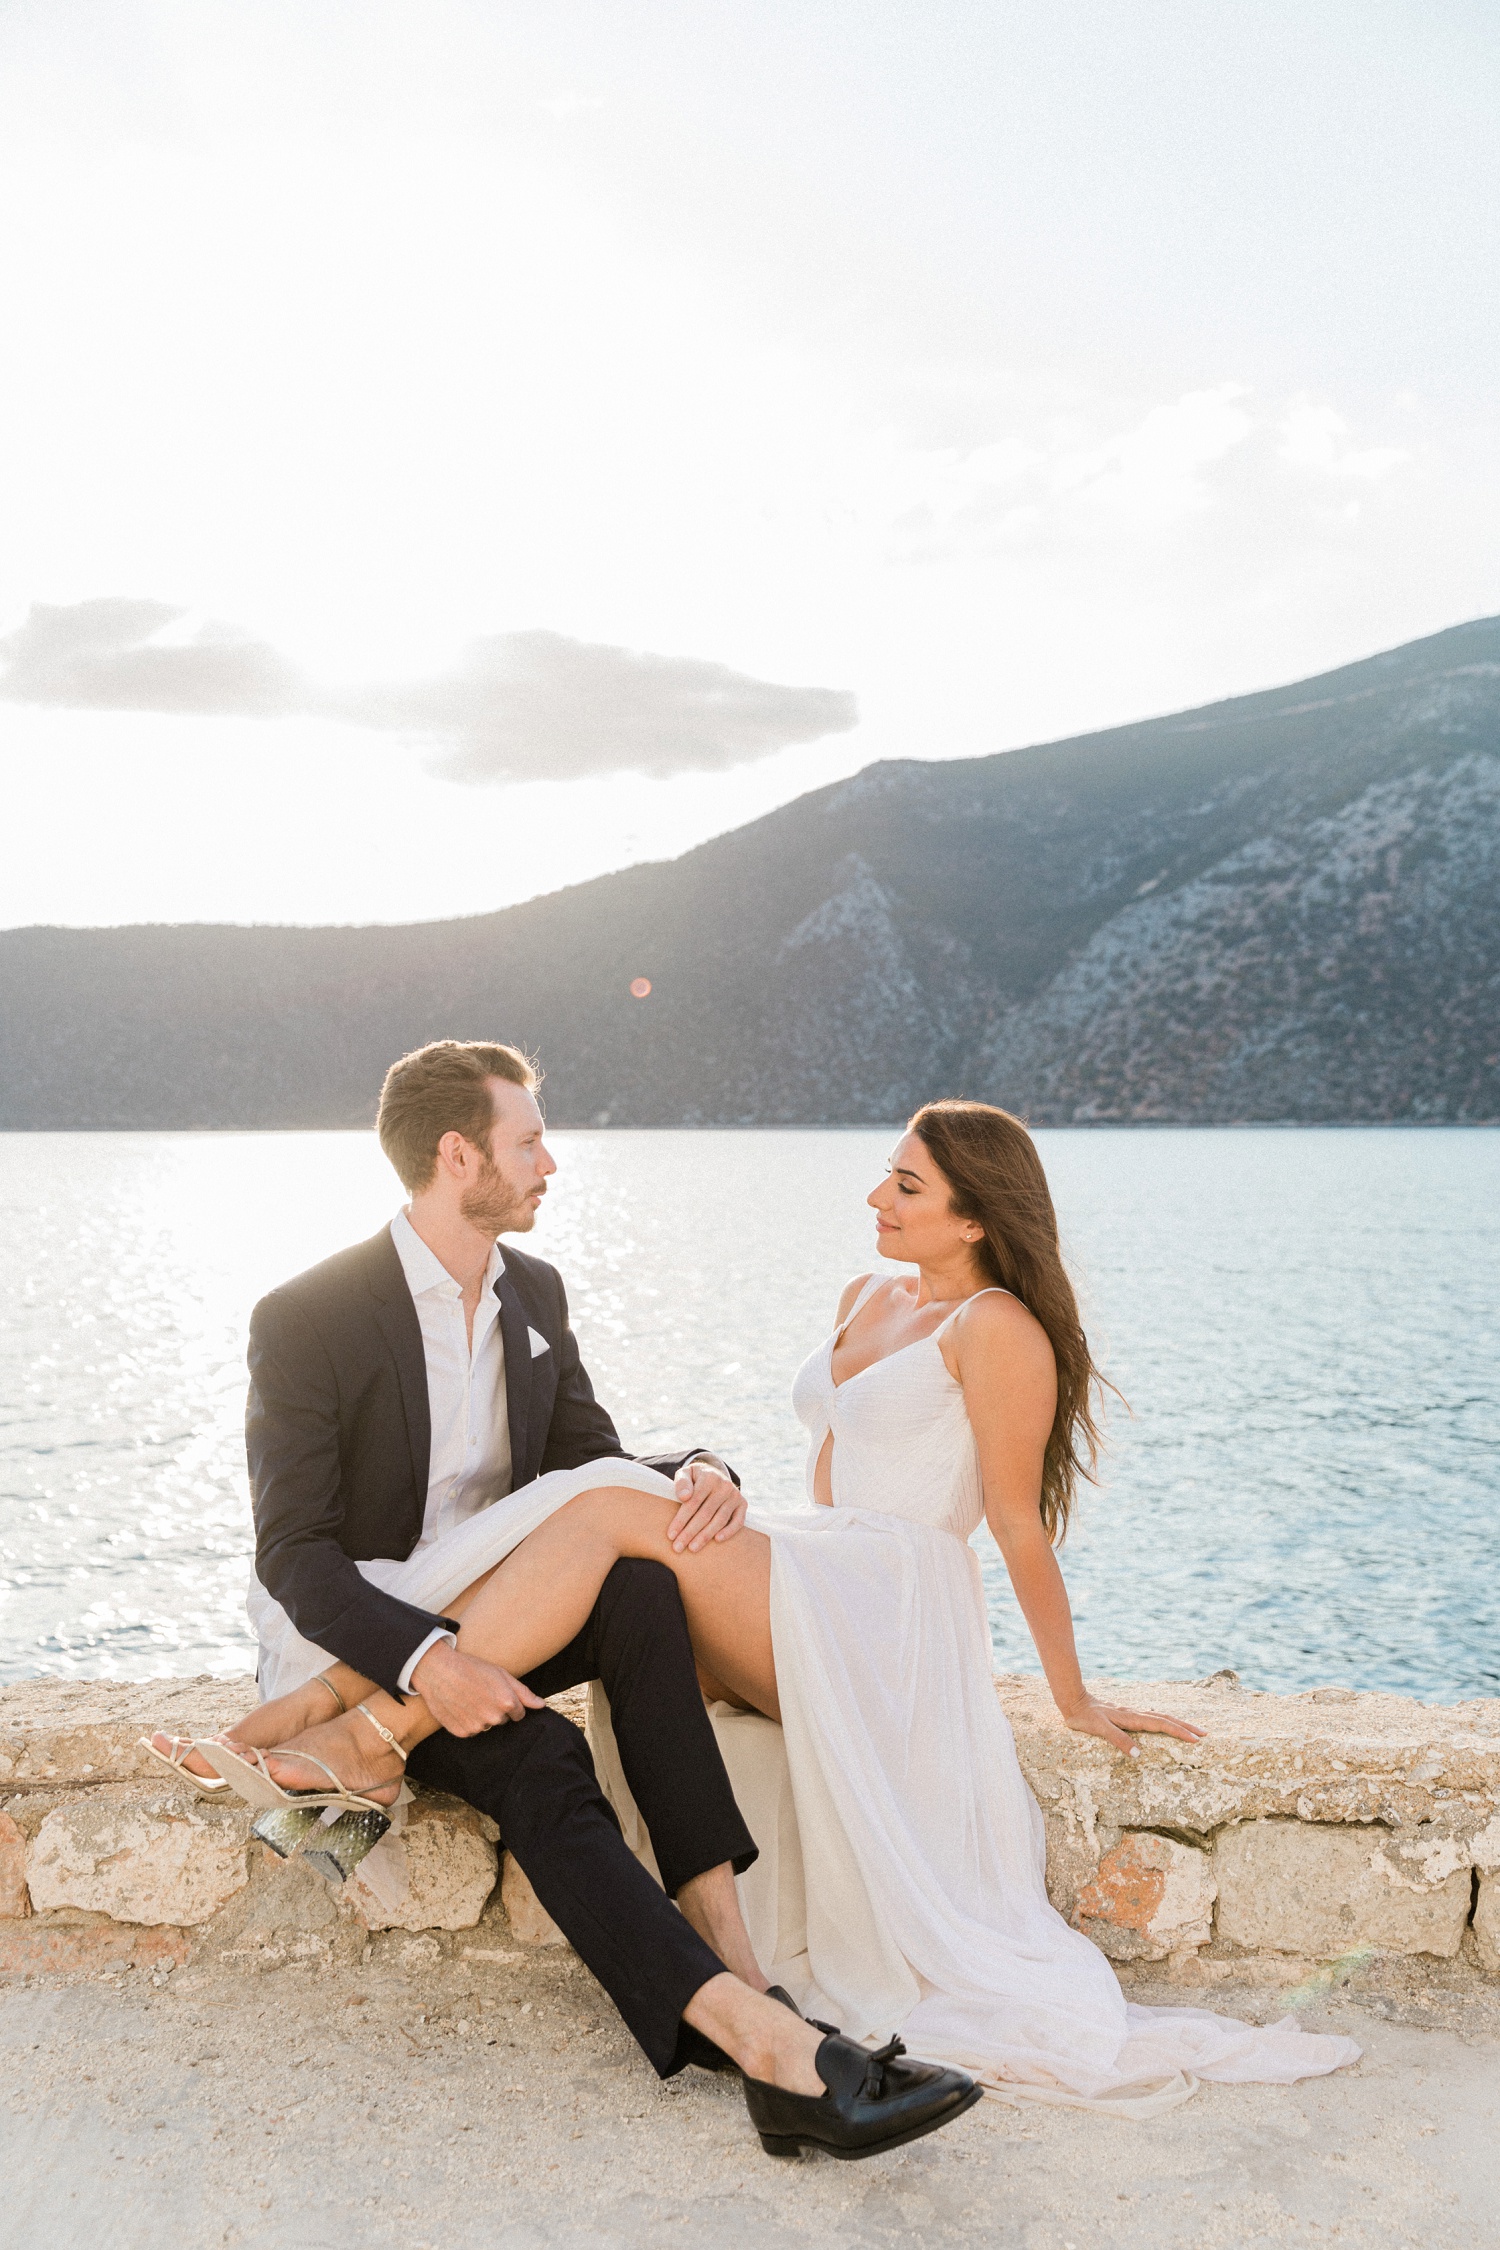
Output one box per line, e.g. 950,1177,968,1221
391,1211,510,1692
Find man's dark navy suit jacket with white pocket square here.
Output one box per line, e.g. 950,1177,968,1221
245,1226,728,1694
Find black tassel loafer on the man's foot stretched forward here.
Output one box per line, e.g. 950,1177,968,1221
744,2032,981,2158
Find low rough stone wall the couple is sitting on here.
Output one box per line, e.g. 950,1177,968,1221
0,1674,1500,1982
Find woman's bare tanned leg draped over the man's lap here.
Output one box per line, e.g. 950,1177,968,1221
249,1485,780,1789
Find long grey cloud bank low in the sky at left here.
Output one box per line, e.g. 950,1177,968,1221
0,599,859,783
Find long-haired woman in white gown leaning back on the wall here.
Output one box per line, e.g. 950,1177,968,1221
161,1103,1358,2113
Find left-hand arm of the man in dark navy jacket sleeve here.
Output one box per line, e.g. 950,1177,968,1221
245,1296,461,1694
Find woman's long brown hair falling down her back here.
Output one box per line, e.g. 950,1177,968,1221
909,1103,1115,1546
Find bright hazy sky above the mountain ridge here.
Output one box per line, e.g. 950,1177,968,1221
0,0,1500,927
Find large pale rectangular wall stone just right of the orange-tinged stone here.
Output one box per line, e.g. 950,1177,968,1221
1214,1820,1471,1960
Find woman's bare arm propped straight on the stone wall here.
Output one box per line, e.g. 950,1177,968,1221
942,1296,1201,1755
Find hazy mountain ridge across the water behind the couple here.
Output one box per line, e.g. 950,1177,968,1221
0,619,1500,1130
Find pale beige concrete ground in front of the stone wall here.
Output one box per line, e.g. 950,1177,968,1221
0,1933,1500,2250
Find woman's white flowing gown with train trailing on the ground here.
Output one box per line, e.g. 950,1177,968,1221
591,1278,1361,2115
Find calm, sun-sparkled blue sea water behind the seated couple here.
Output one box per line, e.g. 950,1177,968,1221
0,1130,1500,1699
